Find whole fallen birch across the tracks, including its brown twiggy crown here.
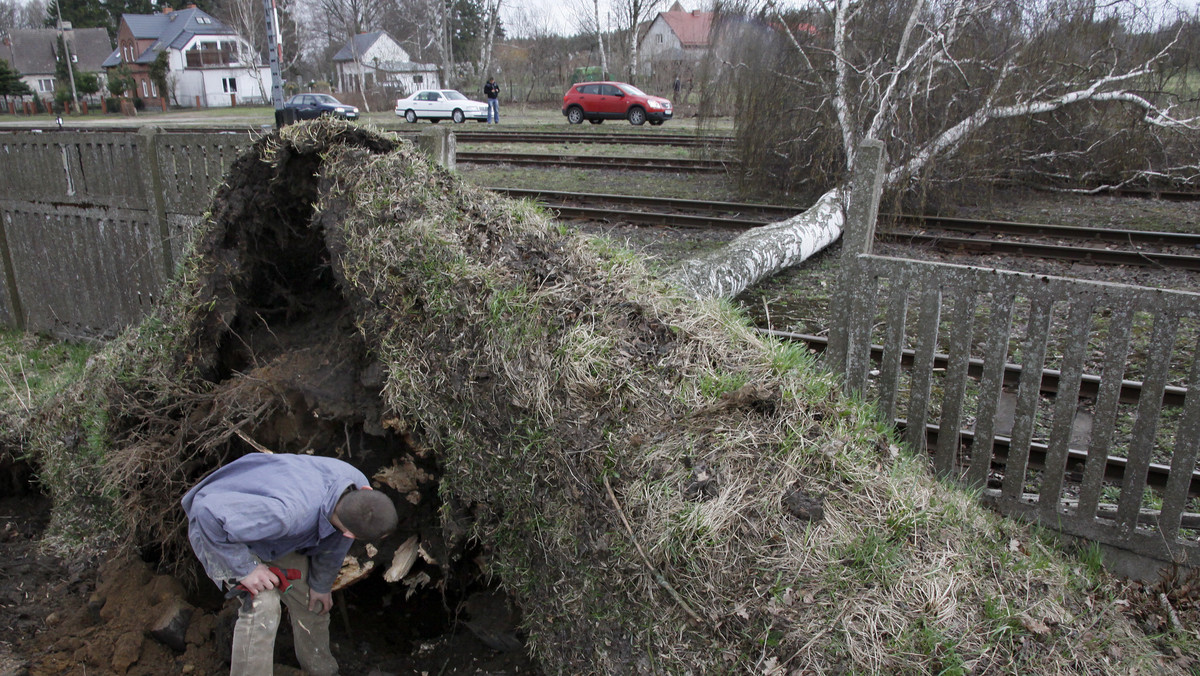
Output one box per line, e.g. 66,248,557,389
676,0,1200,298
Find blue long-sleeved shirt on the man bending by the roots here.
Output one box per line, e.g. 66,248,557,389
182,453,367,593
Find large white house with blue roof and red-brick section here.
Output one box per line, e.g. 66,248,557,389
104,5,271,108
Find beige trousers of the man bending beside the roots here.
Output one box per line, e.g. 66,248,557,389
229,554,337,676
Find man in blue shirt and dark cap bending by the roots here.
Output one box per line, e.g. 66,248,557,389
182,453,397,676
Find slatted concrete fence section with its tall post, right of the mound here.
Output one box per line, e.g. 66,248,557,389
827,142,1200,578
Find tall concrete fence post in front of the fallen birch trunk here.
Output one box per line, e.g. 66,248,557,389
827,138,887,381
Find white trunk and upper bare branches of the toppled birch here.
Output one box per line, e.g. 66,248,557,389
676,0,1200,298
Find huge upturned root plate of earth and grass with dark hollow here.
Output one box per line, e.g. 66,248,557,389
28,121,1175,674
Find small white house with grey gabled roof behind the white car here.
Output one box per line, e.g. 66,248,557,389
334,30,442,96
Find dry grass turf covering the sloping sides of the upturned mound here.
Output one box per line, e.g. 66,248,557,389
18,122,1190,674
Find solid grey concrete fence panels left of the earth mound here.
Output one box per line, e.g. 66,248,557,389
0,127,251,339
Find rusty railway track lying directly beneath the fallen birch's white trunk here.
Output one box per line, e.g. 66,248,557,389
493,189,1200,271
